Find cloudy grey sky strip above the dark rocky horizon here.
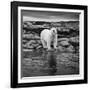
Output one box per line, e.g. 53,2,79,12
21,10,79,22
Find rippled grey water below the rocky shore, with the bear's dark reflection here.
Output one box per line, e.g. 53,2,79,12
21,50,79,77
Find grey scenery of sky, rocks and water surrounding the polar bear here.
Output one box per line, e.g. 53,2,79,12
21,11,79,77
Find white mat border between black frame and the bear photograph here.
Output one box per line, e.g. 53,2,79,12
18,6,84,83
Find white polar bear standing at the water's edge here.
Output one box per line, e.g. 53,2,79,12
40,27,57,50
